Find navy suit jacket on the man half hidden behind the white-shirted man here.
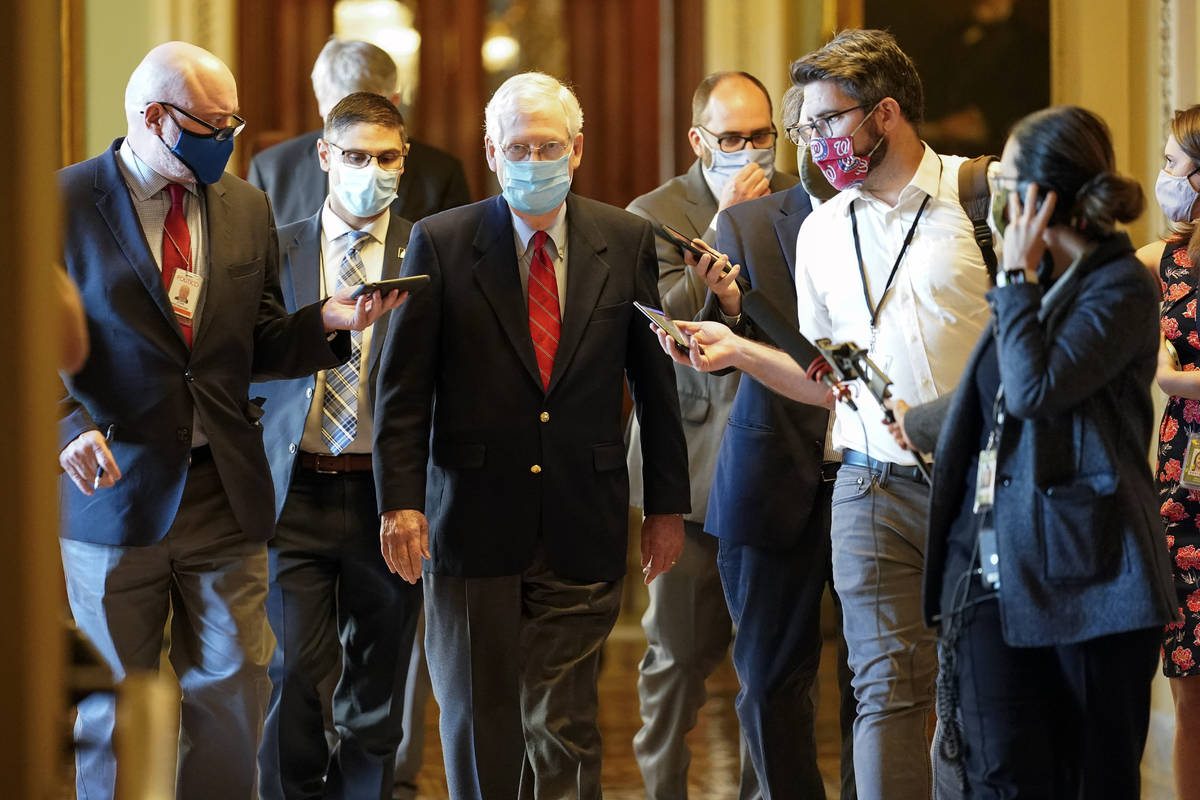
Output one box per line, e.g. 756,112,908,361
703,184,829,549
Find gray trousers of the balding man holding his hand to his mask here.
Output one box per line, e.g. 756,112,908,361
634,522,762,800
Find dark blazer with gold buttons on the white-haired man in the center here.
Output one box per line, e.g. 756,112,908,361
374,194,688,581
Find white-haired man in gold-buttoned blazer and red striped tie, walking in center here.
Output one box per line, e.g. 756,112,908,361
374,73,689,800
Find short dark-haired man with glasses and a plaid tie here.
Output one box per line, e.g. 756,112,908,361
254,92,421,800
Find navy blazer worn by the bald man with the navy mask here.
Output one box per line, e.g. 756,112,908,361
59,139,350,546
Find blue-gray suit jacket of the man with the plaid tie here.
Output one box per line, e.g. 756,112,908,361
253,211,413,518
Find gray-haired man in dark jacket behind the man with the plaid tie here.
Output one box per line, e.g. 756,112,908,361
246,38,470,227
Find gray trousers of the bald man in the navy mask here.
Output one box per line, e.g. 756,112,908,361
61,461,274,800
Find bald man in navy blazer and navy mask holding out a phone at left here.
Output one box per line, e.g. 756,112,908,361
59,42,397,800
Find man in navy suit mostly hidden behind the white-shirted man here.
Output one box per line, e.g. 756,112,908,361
702,86,856,800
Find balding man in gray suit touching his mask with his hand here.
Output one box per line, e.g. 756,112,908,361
628,72,797,799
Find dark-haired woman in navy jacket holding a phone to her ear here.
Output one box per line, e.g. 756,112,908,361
893,107,1176,799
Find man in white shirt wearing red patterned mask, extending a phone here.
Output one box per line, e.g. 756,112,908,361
667,30,989,800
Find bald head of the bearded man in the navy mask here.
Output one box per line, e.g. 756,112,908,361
125,42,238,182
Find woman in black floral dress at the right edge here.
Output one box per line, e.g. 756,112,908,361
1138,106,1200,800
